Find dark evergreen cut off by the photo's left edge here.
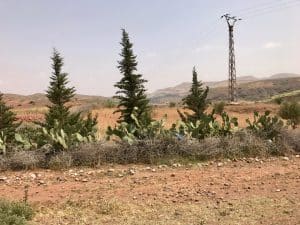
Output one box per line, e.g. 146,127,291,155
0,93,20,142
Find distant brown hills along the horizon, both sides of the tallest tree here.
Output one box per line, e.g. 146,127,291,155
4,73,300,107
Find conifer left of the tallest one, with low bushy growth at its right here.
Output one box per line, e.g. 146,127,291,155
41,49,97,144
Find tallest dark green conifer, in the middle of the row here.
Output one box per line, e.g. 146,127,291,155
115,29,151,125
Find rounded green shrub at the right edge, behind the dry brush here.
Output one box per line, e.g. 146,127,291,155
279,102,300,129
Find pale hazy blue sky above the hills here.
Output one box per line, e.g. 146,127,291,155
0,0,300,96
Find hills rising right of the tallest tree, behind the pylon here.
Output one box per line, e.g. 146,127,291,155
150,74,300,104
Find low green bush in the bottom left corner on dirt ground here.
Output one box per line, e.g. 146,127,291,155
0,200,34,225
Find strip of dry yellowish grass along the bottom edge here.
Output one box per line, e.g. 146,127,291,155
33,197,300,225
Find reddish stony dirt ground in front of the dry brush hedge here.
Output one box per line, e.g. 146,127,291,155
0,156,300,225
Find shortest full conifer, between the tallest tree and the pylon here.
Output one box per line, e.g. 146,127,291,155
178,67,209,122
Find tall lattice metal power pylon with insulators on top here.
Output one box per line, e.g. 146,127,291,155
221,14,241,102
